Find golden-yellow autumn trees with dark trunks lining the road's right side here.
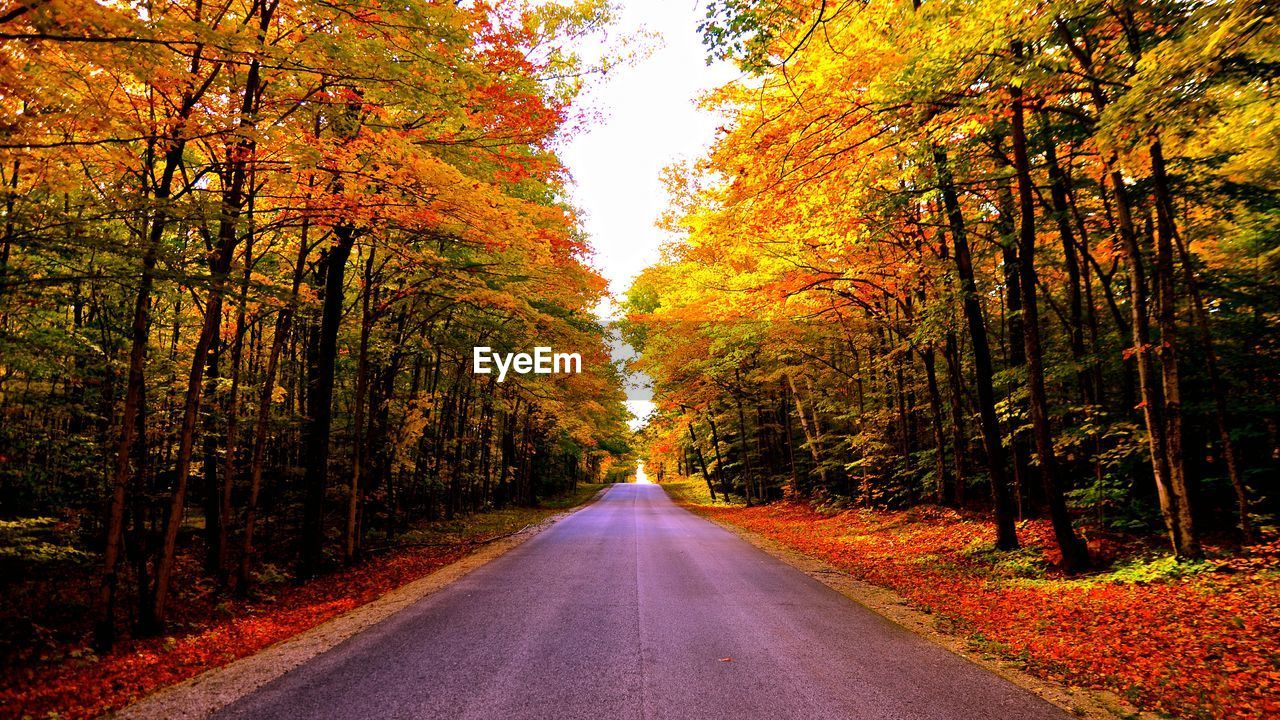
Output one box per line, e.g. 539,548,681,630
628,0,1280,570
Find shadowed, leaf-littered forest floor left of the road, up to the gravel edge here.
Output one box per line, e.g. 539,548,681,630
0,484,604,720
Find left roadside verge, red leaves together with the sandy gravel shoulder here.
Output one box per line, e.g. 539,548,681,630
0,484,607,720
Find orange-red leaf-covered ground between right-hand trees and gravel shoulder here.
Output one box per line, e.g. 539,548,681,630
663,480,1280,720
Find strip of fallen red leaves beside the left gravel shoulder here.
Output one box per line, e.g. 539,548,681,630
0,544,468,720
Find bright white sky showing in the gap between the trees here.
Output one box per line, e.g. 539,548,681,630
559,0,736,425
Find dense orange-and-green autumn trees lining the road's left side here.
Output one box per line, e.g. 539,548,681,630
0,0,626,646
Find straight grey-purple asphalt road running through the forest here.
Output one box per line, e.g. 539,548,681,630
216,484,1068,720
